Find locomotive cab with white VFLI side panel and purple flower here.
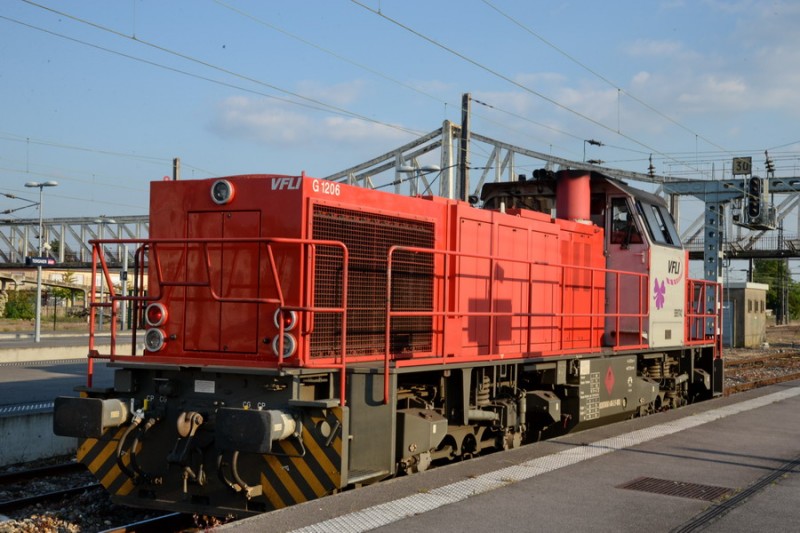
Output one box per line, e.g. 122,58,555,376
481,170,688,348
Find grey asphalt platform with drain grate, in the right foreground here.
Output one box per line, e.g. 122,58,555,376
223,381,800,533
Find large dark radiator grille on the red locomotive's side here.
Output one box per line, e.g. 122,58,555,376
311,205,434,357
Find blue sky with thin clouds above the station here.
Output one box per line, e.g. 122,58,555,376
0,0,800,218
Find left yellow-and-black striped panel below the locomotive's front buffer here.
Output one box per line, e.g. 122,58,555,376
78,427,141,496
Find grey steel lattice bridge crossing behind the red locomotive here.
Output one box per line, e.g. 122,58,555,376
0,121,800,274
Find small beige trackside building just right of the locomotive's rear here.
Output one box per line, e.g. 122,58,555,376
723,281,769,348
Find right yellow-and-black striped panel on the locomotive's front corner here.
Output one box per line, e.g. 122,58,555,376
261,407,346,509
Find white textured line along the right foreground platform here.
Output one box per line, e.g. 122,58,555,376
292,387,800,533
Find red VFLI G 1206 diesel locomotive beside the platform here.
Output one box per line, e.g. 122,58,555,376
54,171,722,516
